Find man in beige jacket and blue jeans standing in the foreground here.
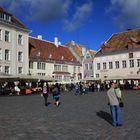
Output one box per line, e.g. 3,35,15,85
107,82,122,127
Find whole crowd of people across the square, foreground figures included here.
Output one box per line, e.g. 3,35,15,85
1,79,123,127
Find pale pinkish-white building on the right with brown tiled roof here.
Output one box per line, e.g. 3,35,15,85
94,29,140,80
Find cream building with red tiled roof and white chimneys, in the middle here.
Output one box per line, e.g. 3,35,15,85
29,36,83,83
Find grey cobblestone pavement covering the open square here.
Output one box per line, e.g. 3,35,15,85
0,91,140,140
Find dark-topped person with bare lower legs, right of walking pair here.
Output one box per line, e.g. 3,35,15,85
52,83,60,107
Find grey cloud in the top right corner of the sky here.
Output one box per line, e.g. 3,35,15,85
109,0,140,28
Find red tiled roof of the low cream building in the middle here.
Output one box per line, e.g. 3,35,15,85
29,37,78,63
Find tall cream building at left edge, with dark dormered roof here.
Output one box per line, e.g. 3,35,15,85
0,7,30,75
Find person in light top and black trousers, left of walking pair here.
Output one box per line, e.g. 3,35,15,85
42,82,49,106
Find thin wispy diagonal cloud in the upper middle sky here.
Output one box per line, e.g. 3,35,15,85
64,1,93,31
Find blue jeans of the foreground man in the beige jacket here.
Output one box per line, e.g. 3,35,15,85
111,105,122,126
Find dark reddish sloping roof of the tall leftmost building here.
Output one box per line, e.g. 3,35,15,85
0,7,30,30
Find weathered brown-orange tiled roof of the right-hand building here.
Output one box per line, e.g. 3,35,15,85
96,29,140,55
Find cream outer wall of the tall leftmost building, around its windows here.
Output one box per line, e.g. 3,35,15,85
0,24,29,75
